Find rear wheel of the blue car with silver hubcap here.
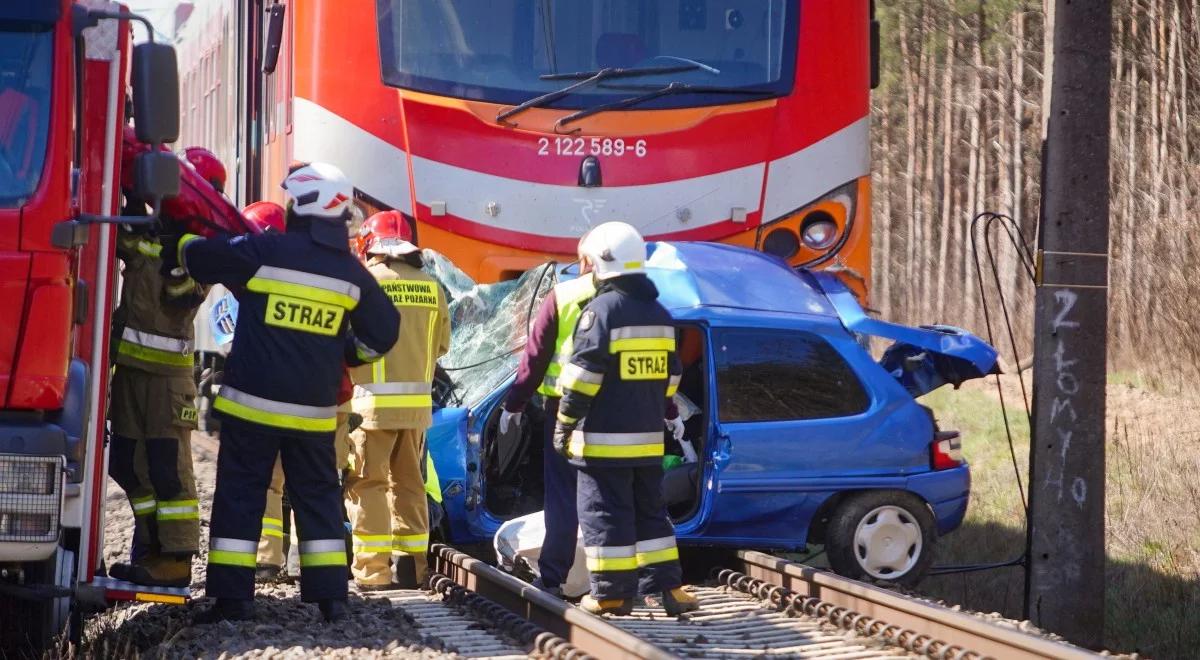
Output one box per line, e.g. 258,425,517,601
826,491,937,587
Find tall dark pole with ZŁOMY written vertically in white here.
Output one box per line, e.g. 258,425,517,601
1025,0,1112,648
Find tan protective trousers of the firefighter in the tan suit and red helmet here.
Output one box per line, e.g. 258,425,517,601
346,428,430,584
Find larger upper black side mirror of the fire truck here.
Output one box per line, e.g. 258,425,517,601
133,42,179,145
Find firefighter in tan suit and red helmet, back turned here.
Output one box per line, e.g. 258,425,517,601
346,211,450,590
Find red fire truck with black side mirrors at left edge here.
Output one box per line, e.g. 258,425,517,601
0,0,182,655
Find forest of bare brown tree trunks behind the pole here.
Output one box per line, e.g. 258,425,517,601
871,0,1200,391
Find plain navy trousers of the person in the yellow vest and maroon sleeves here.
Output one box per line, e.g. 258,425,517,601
538,396,580,587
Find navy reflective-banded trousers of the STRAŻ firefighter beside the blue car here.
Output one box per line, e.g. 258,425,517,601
577,464,683,600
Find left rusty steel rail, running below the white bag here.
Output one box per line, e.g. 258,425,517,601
430,544,677,660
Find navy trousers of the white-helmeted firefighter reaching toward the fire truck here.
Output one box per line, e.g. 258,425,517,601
206,420,349,602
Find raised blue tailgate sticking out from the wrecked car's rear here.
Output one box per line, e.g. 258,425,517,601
814,272,998,397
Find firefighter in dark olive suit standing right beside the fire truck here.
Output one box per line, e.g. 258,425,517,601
109,193,205,587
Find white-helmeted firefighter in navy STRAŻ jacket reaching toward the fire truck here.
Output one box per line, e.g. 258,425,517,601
163,163,400,623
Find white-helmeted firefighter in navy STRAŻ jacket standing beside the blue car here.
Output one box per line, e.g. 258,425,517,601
553,222,698,616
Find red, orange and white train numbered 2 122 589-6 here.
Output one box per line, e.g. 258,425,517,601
179,0,878,301
